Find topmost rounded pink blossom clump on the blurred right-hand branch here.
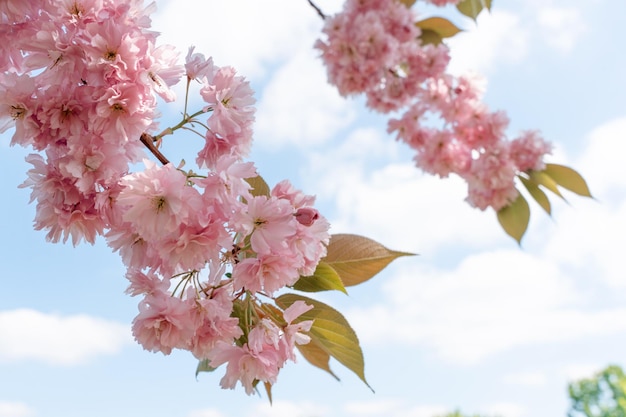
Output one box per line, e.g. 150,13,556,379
315,0,449,113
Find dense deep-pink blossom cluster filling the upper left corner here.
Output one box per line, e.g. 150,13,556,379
0,0,183,244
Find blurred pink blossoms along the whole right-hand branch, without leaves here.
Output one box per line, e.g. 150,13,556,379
316,0,551,211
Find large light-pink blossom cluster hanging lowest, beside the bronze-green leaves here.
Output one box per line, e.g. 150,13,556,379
117,156,329,393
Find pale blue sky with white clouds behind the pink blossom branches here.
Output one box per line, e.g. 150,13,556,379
0,0,626,417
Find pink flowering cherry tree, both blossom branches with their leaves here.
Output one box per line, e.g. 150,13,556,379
0,0,590,399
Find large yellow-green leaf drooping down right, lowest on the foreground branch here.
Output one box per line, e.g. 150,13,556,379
276,294,373,391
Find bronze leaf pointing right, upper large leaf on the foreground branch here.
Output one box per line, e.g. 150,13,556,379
322,234,414,287
